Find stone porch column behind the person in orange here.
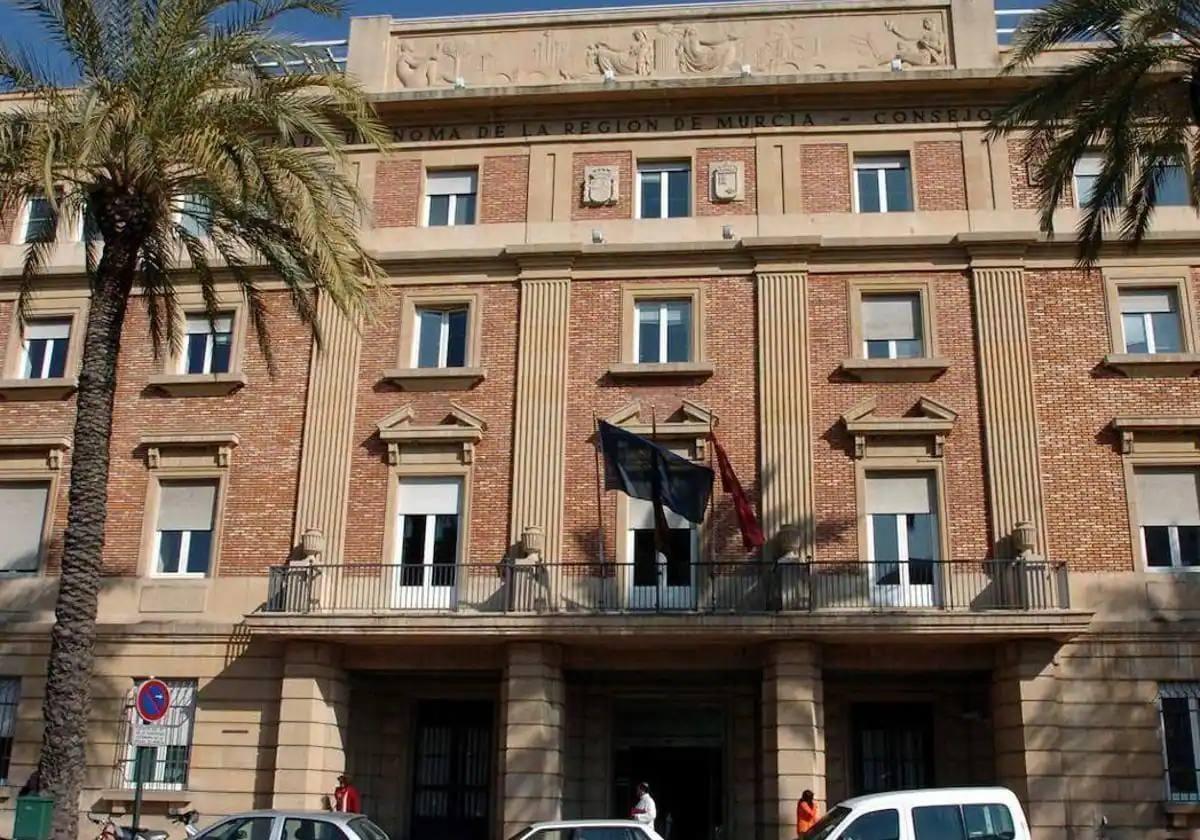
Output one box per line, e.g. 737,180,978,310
760,642,826,840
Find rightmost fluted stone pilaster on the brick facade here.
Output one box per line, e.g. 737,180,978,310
972,259,1046,557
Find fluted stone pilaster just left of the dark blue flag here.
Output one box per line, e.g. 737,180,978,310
510,265,571,563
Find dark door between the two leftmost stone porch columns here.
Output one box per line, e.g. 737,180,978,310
410,701,492,840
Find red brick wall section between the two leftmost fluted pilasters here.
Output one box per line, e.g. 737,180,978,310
346,283,518,563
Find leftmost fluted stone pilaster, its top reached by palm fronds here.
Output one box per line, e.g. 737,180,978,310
295,295,362,563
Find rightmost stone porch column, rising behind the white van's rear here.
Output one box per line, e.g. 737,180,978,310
991,642,1067,840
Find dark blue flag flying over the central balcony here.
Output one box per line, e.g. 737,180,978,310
600,421,713,524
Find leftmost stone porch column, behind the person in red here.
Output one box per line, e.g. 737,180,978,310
274,642,350,809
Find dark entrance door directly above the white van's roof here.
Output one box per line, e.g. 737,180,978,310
851,703,934,796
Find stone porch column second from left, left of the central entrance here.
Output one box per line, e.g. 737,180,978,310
502,642,564,836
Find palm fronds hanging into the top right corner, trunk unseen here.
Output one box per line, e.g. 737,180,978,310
991,0,1200,263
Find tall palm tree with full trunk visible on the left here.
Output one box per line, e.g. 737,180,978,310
0,0,385,840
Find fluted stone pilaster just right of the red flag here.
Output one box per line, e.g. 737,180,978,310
757,271,814,556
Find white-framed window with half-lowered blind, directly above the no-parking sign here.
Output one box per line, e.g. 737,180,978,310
154,479,217,577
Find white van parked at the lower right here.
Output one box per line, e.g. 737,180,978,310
804,787,1030,840
